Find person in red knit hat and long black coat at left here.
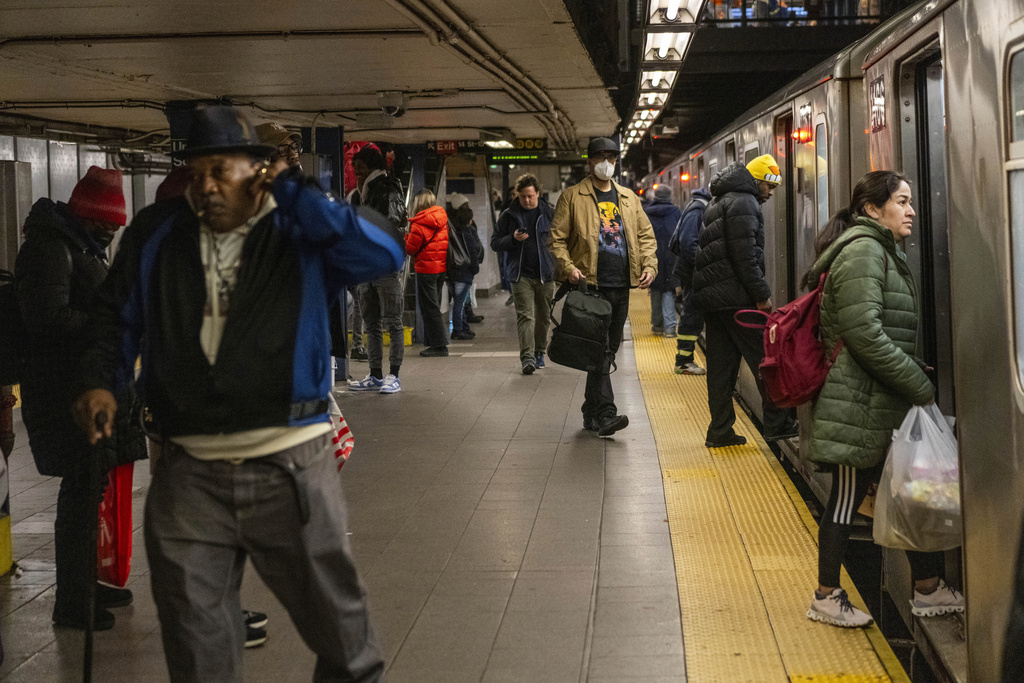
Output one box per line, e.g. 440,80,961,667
14,166,145,630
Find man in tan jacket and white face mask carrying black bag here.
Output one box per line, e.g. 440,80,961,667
549,137,657,436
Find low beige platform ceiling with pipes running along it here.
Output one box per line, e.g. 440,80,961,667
0,0,618,148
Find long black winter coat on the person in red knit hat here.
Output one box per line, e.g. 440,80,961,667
14,198,145,476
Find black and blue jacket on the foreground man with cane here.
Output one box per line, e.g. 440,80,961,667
80,173,404,437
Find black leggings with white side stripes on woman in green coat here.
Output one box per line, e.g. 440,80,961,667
818,461,943,588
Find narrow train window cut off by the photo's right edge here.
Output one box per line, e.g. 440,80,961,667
1008,50,1024,385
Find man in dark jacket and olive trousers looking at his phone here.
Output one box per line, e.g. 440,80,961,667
490,173,555,375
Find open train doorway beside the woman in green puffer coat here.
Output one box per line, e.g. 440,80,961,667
899,42,955,415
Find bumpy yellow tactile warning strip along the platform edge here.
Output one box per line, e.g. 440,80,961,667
630,292,909,683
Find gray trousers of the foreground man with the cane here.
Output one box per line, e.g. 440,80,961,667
145,436,384,683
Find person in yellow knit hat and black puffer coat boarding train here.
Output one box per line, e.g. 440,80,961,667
693,155,797,449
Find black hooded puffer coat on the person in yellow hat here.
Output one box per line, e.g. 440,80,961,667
693,162,771,312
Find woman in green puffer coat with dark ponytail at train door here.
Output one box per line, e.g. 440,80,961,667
807,171,964,627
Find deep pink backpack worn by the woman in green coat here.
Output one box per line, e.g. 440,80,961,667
734,271,843,408
